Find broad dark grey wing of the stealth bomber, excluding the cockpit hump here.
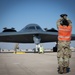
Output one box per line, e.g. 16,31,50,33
0,31,75,43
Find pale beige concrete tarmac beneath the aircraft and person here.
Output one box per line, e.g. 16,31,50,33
0,52,75,75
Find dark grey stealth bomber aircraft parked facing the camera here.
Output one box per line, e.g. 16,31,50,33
0,24,75,44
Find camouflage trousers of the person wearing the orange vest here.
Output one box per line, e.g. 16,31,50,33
57,41,71,67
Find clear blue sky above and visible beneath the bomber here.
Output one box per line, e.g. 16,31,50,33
0,0,75,49
